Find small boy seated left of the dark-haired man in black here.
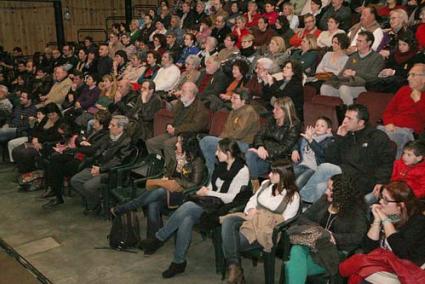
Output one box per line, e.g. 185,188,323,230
291,116,334,188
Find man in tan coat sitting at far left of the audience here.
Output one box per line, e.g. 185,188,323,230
37,66,72,108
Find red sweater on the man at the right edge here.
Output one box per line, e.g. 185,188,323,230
383,86,425,134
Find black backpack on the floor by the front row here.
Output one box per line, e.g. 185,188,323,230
107,211,140,251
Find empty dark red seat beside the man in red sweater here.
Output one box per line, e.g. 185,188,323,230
357,92,394,126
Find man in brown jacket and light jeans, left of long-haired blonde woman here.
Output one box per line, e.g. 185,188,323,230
199,88,260,176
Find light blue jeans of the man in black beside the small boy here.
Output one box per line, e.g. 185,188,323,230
300,163,342,203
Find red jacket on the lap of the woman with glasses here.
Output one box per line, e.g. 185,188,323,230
339,248,425,284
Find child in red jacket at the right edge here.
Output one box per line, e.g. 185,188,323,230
391,140,425,199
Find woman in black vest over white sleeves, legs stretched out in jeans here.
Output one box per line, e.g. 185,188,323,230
143,138,249,278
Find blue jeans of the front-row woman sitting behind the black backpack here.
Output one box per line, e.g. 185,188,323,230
115,188,167,236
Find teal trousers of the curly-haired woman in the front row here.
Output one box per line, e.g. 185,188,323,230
285,245,325,284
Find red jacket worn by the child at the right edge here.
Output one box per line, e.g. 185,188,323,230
391,159,425,199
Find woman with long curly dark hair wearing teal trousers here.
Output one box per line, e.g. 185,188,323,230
285,174,368,284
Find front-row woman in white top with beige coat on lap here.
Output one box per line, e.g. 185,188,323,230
221,167,300,283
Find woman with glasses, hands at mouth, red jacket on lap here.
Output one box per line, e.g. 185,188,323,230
340,182,425,283
